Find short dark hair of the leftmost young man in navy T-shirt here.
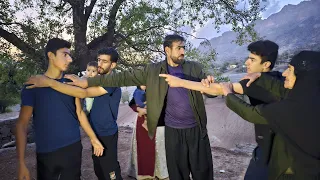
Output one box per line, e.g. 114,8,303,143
45,38,71,60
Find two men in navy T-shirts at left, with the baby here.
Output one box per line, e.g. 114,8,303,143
17,38,122,180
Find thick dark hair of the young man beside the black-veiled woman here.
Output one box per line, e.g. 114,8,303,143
248,40,279,70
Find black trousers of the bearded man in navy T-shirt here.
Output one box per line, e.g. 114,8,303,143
92,132,122,180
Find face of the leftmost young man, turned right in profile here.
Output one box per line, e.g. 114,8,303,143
48,48,72,71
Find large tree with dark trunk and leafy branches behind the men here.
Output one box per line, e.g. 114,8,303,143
0,0,262,70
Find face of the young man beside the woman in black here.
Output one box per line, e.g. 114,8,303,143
245,53,270,73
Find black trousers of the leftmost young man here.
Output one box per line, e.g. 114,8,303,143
37,141,82,180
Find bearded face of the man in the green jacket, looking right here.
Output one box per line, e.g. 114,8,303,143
166,41,185,64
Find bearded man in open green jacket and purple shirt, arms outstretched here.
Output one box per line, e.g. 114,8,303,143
25,35,213,180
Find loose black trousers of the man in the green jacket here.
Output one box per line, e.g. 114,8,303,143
165,126,213,180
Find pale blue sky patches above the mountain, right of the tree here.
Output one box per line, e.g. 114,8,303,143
189,0,304,47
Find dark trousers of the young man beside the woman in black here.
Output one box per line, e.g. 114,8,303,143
244,146,268,180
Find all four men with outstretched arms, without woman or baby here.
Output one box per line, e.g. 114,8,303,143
17,34,279,180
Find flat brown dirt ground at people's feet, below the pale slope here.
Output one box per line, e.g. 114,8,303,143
0,127,250,180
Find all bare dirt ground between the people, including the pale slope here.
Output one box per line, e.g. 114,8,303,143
0,98,254,180
